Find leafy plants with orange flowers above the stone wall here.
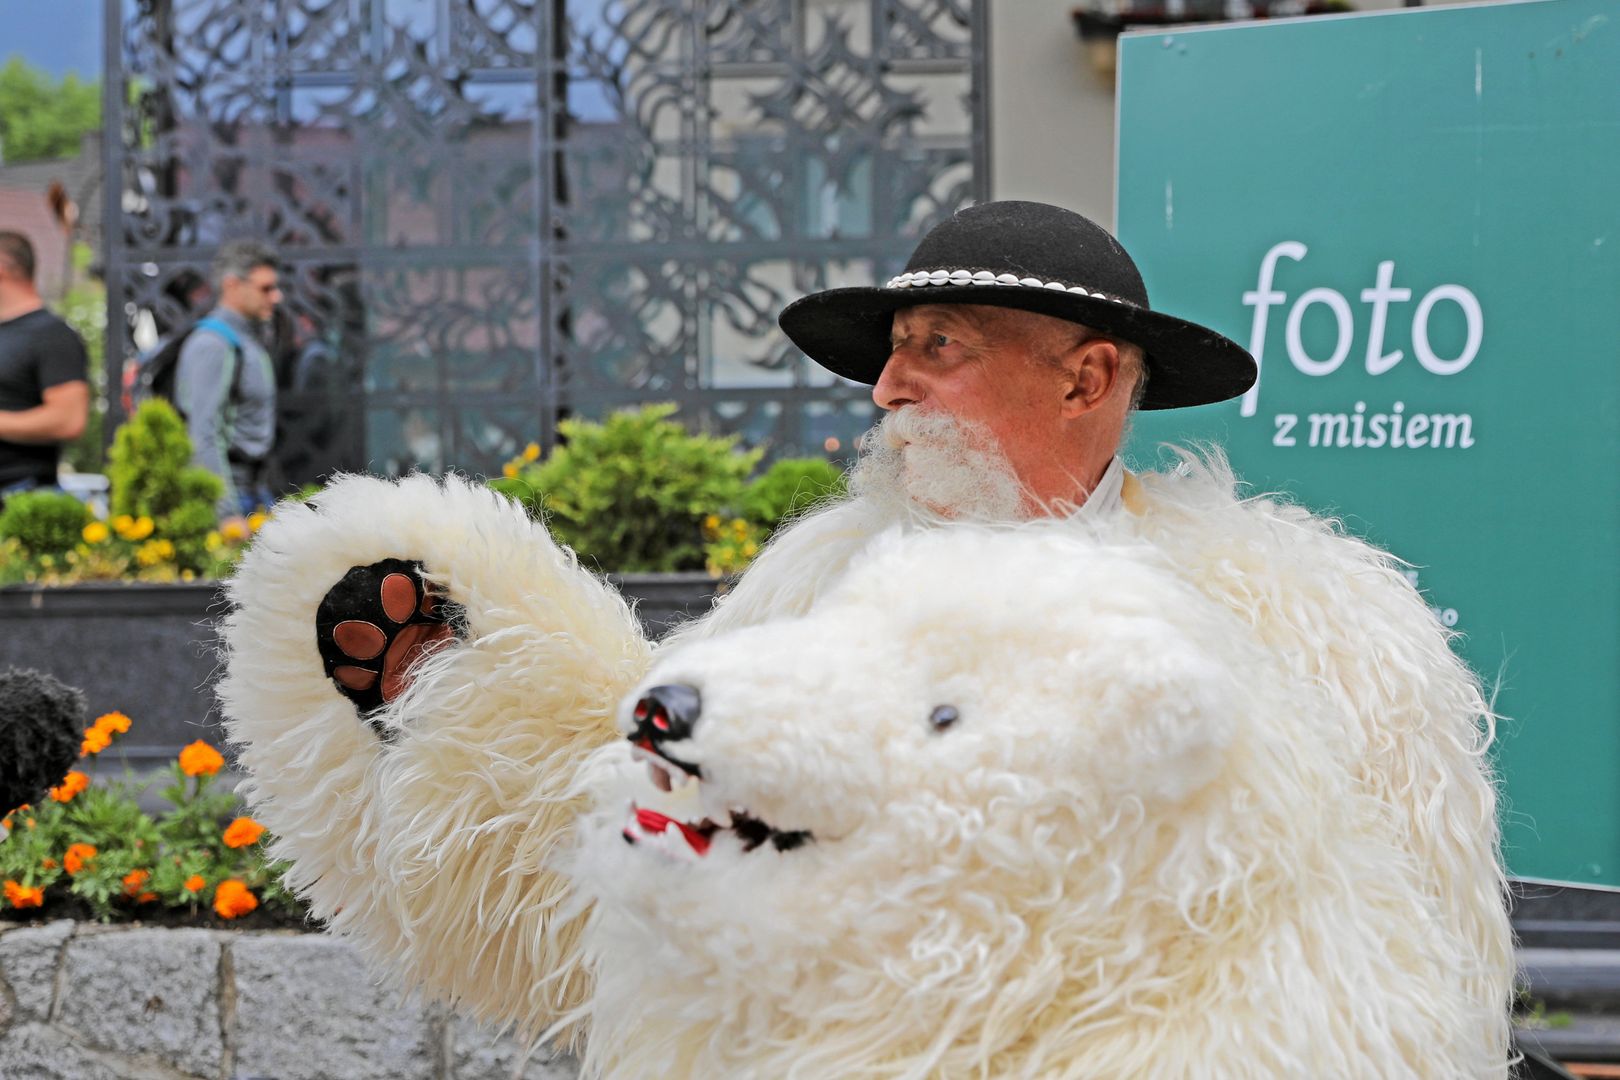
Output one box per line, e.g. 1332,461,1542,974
0,718,298,921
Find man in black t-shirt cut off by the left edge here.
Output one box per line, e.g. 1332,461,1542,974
0,232,91,507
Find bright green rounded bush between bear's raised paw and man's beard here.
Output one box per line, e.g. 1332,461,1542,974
511,405,761,573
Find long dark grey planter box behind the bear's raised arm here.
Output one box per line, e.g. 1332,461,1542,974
0,573,721,767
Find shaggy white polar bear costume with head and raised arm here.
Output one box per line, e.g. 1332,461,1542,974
220,458,1511,1080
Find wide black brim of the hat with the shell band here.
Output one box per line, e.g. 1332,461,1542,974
778,285,1259,410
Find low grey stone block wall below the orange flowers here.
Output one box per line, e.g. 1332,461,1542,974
0,920,578,1080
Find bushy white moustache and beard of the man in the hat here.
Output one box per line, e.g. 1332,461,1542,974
849,405,1030,521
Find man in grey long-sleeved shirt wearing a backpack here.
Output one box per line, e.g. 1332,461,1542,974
173,240,282,526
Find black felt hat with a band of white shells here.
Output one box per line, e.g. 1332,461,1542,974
779,202,1259,408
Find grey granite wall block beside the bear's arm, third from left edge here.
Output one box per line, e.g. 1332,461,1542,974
230,934,439,1080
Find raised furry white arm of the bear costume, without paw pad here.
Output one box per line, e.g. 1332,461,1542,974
219,476,648,1033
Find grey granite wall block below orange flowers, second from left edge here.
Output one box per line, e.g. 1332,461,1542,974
57,929,224,1077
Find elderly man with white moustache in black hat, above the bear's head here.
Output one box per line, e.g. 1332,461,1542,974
672,202,1256,641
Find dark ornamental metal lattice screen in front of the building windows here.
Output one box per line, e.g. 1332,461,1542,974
104,0,988,481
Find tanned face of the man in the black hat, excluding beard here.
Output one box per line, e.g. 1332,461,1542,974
872,304,1084,508
